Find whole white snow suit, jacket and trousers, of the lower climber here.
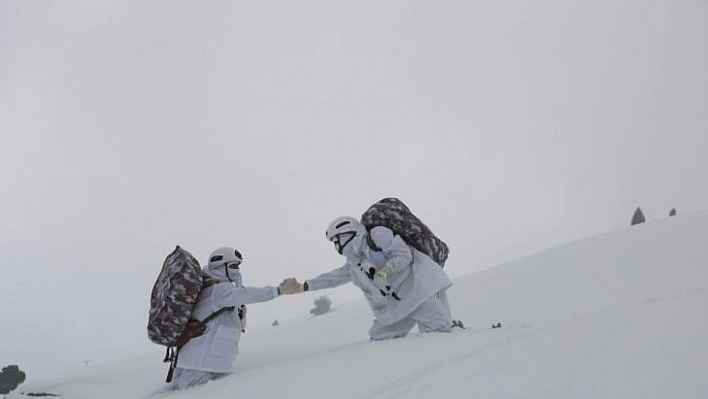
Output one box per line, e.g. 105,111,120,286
162,266,278,391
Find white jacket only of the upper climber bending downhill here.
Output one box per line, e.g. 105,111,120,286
307,226,452,325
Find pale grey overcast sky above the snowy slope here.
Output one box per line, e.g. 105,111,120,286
0,0,708,382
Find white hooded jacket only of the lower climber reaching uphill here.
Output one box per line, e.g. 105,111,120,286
177,268,278,373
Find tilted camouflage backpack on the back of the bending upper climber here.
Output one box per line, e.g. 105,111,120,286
361,197,450,267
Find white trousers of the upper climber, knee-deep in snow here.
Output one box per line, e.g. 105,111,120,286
369,291,452,341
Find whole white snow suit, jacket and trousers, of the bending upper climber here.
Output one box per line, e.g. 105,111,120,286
307,226,452,340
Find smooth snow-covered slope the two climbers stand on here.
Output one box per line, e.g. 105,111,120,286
16,213,708,399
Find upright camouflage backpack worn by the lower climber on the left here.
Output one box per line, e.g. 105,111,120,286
147,246,203,347
